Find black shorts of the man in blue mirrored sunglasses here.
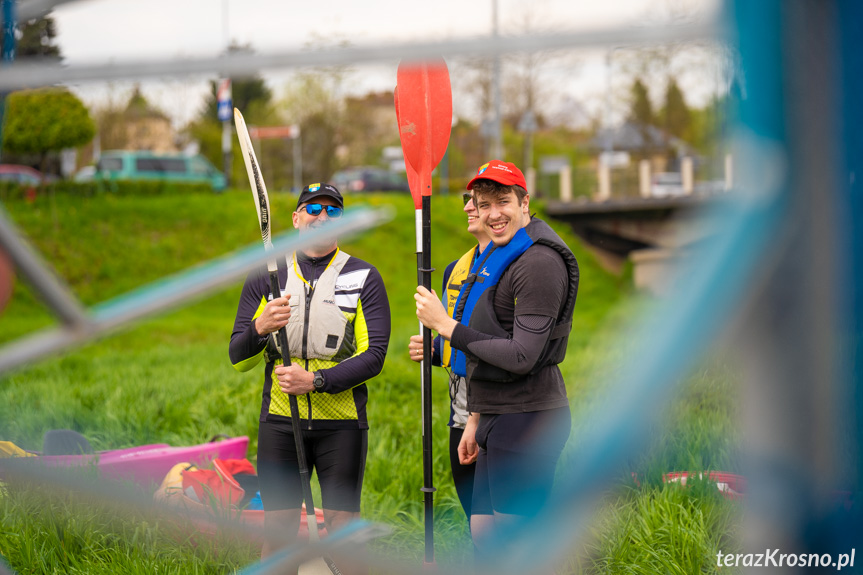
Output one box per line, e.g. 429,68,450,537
258,421,368,513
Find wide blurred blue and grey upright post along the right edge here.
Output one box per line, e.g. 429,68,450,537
732,0,863,572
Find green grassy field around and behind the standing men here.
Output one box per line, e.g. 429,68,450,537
0,187,738,573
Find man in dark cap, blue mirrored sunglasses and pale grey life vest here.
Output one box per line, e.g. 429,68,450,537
230,183,390,557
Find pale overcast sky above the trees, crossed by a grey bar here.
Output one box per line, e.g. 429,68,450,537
47,0,718,126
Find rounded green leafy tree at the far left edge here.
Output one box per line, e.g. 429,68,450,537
3,88,96,169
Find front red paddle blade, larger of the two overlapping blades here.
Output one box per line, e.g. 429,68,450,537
396,59,452,207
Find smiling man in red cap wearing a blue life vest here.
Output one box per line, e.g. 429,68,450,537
414,160,578,552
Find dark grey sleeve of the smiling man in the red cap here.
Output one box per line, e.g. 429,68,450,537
451,246,568,374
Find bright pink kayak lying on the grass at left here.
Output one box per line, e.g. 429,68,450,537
27,436,249,489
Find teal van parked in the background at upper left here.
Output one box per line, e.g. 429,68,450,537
93,150,226,190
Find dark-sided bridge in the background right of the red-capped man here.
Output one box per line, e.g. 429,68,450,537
546,193,728,295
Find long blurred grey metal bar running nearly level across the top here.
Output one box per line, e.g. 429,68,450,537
0,22,723,91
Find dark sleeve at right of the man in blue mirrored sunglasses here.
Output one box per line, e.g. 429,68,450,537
321,267,390,393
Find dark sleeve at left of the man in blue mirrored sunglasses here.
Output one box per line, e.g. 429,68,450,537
228,270,270,371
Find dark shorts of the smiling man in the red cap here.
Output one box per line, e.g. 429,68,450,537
471,406,572,515
